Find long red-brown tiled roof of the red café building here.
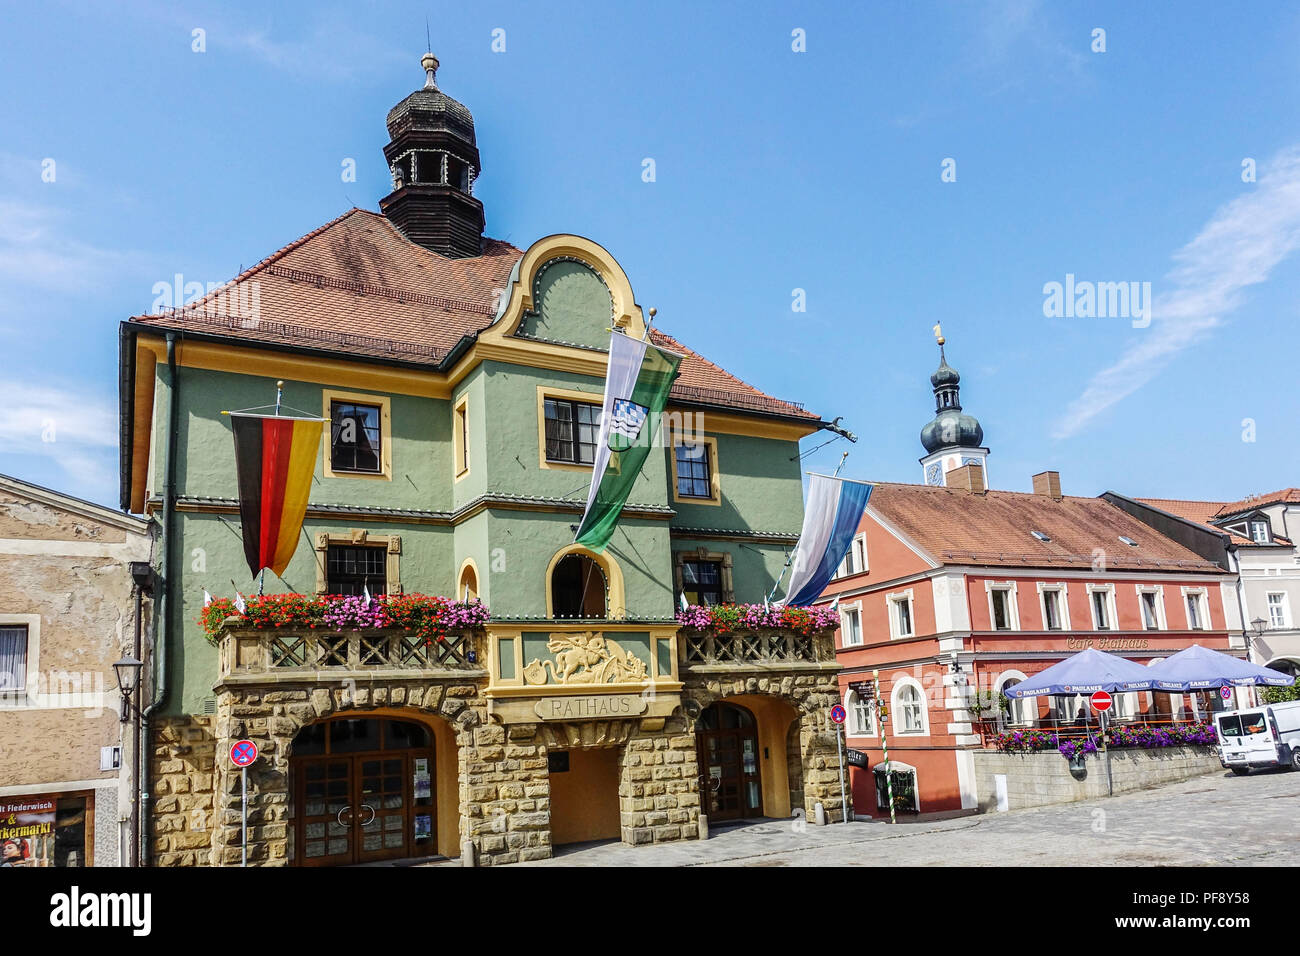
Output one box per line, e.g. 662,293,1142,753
868,483,1218,571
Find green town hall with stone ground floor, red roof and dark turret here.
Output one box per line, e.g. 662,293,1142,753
120,55,841,866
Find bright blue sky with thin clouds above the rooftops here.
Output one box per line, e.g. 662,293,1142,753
0,1,1300,505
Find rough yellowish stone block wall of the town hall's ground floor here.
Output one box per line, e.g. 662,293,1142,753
152,629,842,866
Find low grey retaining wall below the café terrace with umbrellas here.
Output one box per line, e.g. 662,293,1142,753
972,747,1222,812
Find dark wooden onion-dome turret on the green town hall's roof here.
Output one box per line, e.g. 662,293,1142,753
380,53,484,259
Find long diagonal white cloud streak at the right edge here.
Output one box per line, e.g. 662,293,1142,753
1053,147,1300,438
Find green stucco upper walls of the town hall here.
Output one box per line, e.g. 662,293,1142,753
148,260,802,714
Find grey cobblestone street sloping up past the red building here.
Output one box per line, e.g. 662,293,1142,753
523,771,1300,866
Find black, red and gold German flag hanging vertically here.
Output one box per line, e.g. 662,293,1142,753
230,414,324,576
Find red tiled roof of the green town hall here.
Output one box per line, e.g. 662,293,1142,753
133,209,818,421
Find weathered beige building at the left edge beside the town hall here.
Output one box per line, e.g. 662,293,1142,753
0,476,151,866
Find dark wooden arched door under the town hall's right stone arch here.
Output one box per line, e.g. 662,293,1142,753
696,701,763,823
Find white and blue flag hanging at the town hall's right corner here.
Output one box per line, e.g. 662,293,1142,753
785,475,871,607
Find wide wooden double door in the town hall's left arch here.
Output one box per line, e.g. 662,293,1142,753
289,715,438,866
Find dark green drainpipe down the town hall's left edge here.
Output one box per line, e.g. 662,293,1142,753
139,332,181,866
